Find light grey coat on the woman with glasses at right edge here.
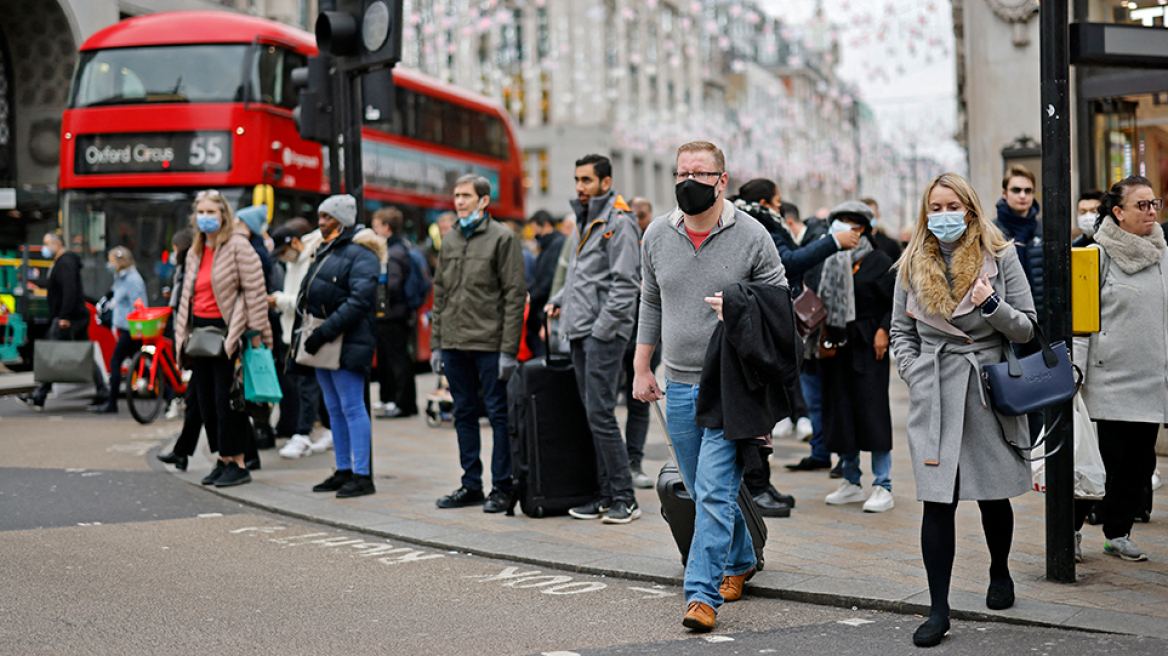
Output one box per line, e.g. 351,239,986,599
1075,219,1168,424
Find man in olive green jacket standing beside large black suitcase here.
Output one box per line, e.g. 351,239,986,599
430,174,527,512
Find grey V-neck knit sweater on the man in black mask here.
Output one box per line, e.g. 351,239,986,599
637,202,787,385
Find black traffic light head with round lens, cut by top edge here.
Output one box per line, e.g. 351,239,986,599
317,0,402,71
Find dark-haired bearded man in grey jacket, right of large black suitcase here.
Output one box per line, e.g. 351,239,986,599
545,155,641,524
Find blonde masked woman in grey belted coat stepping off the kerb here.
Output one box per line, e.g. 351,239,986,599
891,173,1036,647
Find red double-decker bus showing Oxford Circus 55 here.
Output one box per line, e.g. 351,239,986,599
60,12,523,308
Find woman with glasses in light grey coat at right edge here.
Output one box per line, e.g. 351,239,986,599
1075,175,1168,560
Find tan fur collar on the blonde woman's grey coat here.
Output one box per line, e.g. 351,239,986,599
909,221,985,320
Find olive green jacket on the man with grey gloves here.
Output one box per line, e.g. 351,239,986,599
430,216,527,355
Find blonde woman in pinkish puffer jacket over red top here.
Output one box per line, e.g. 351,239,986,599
174,190,272,487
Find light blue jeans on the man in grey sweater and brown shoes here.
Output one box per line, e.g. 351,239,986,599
666,381,755,609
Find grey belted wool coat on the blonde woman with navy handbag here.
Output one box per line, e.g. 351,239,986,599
891,247,1036,503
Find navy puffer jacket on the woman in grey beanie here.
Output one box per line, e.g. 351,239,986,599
290,225,387,376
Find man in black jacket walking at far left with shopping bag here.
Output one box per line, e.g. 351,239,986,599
18,232,109,412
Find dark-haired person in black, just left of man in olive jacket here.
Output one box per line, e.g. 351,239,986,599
373,208,418,419
